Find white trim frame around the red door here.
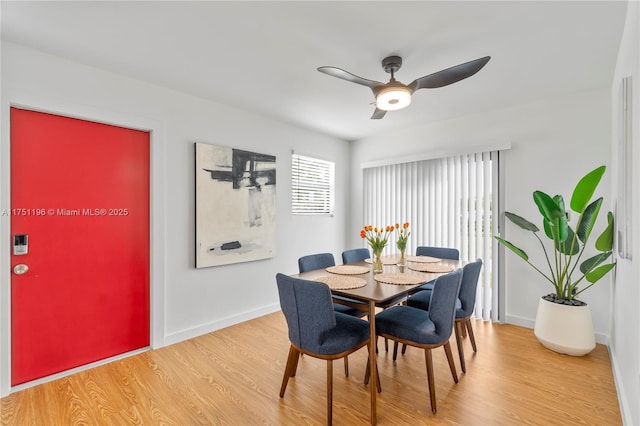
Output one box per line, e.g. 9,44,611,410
0,97,165,397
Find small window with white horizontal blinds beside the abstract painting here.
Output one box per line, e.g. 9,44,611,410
291,154,335,216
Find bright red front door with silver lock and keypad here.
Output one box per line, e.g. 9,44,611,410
10,108,149,386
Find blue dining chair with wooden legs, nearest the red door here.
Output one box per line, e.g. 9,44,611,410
276,274,369,425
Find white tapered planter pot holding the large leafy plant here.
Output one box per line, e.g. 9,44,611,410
534,298,596,356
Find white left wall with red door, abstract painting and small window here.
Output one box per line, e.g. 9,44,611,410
0,42,350,395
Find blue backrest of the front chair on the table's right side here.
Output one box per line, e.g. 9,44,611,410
429,268,462,340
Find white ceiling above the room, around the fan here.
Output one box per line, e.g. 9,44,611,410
0,0,626,140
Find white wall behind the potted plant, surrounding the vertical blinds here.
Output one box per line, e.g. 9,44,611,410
348,89,611,343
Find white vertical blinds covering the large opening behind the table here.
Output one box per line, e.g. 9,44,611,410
363,151,499,320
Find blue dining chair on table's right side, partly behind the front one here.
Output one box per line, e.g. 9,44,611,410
408,259,482,373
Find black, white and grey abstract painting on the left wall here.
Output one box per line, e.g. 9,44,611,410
195,142,276,268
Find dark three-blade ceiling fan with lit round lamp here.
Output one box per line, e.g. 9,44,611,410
318,56,491,119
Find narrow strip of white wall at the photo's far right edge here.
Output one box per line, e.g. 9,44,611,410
610,1,640,425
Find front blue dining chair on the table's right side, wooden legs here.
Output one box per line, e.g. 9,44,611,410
376,269,462,413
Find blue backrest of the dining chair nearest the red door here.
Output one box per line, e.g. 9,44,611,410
276,273,336,353
